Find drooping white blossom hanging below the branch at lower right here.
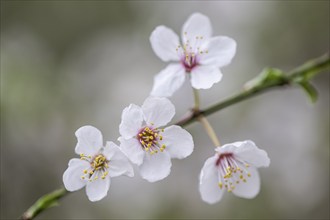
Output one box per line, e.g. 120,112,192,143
199,141,270,204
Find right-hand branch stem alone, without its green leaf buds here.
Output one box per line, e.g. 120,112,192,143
176,54,330,127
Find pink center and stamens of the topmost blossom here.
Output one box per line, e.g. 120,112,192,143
176,32,208,73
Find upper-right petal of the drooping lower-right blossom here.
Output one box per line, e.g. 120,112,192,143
233,140,270,167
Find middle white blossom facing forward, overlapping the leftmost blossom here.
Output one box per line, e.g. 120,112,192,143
118,97,194,182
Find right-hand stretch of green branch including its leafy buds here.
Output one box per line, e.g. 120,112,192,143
176,54,330,127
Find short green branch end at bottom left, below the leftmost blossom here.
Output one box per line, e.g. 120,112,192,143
21,188,69,220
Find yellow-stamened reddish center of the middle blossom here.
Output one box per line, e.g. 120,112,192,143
137,126,166,155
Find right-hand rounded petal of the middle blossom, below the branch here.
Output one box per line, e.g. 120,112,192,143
161,125,194,159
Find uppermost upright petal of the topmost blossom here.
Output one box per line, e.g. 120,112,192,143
181,13,212,45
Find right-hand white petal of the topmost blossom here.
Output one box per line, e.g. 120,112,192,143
198,36,236,67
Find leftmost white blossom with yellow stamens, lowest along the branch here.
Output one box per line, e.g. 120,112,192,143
63,126,134,202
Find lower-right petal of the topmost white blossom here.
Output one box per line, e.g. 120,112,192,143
191,66,222,89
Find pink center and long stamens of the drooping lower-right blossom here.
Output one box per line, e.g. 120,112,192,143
215,153,251,192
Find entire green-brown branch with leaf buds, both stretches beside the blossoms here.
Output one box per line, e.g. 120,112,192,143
21,52,330,220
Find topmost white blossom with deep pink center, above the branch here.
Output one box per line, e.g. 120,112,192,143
150,13,236,97
